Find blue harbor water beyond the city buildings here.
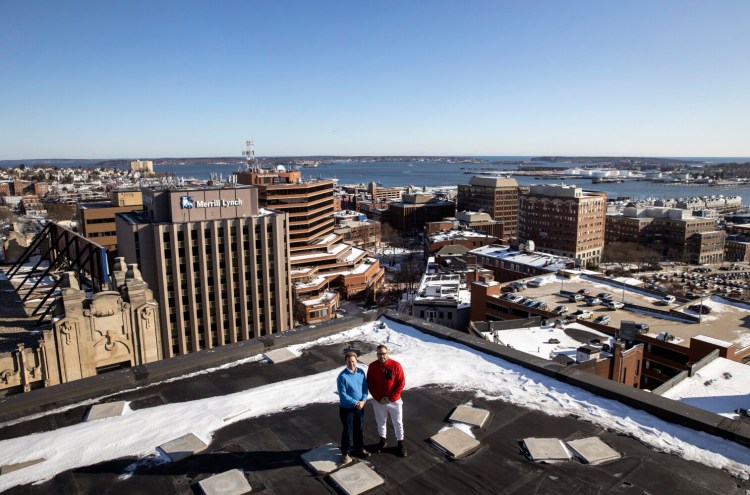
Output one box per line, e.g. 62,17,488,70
150,157,750,204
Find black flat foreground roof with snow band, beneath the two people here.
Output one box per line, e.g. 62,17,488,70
0,320,750,495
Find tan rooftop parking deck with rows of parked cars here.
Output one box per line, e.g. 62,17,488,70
508,275,750,348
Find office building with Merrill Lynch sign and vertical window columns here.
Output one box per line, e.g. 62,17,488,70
116,187,293,357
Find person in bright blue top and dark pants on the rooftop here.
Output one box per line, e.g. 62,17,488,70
336,352,370,464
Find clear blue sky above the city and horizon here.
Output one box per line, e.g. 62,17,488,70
0,0,750,159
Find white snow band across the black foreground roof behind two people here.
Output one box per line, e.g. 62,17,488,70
0,319,750,493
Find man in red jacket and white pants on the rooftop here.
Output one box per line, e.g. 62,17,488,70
367,345,406,457
